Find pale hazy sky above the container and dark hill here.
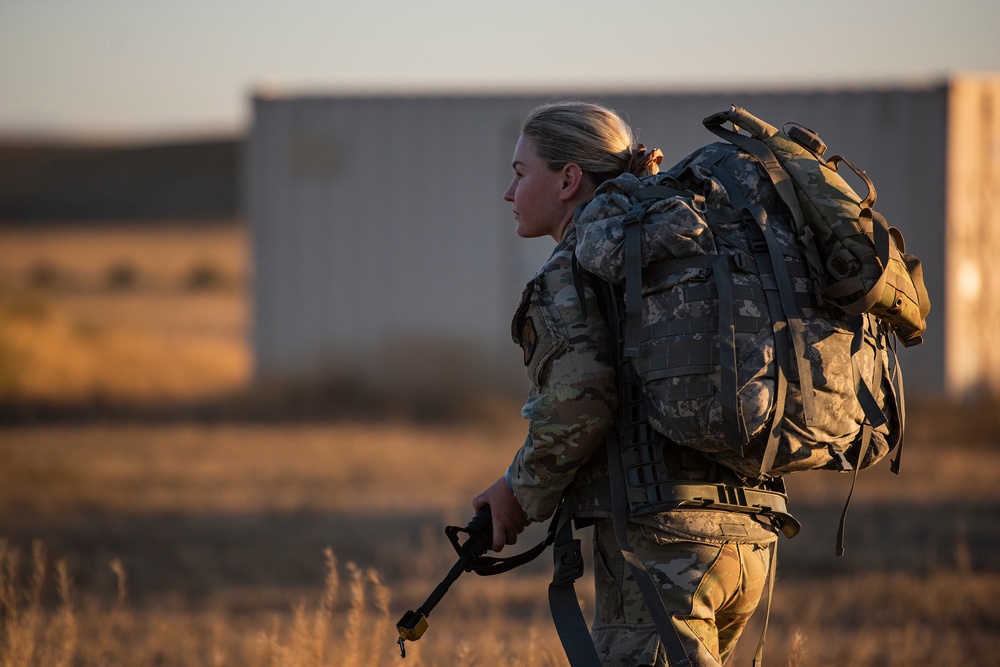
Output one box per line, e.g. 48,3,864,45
0,0,1000,138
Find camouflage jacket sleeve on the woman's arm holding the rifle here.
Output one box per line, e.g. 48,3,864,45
507,256,617,521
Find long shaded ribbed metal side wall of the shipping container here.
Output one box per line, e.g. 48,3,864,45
246,82,996,400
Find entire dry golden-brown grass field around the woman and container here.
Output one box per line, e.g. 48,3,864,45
0,225,1000,667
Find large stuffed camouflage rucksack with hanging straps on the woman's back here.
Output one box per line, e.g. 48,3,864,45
576,107,929,486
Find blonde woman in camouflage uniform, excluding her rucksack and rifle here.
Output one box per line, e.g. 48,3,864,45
473,102,775,666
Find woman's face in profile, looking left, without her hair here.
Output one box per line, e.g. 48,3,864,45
503,136,572,241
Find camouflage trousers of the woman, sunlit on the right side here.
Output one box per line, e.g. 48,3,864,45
591,519,774,667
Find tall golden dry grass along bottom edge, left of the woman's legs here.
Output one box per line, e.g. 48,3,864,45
0,540,564,667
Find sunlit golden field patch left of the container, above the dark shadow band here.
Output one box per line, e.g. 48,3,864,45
0,224,249,406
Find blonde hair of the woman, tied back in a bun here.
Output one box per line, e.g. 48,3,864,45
521,101,663,185
